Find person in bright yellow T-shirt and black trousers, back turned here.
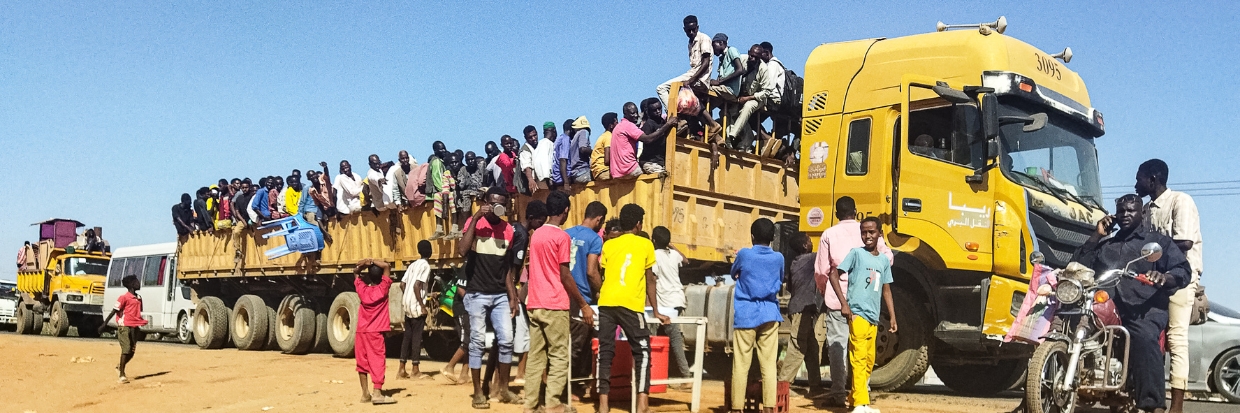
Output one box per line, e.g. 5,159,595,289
597,203,672,413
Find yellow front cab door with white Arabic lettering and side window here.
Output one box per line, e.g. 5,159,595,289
893,76,993,272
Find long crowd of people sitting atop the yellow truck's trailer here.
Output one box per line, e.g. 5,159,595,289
172,16,800,242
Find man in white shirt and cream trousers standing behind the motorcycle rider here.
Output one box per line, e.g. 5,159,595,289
1133,159,1202,413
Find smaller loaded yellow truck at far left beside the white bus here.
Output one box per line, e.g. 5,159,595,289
16,220,112,337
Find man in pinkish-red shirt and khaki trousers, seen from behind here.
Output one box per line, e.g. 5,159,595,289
526,191,594,413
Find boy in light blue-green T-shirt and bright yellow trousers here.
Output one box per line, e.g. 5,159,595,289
831,217,897,413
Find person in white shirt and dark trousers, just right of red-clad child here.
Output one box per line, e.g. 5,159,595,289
397,239,432,380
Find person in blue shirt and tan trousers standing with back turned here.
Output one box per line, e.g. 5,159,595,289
730,218,784,413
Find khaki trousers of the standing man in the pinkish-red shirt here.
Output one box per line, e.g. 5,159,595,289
526,309,569,411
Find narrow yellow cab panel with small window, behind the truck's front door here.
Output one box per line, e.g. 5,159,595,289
825,109,892,222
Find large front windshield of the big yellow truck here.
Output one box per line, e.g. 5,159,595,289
999,98,1102,206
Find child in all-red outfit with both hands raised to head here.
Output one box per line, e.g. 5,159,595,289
353,258,396,404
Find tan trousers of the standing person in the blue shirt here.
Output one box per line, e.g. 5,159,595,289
724,321,779,411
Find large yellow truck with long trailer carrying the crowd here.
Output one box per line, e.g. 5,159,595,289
179,20,1105,394
